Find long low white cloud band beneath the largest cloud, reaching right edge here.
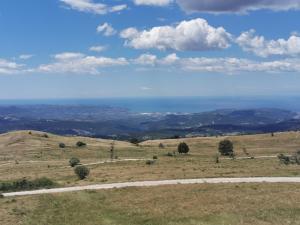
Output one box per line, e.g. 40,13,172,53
134,54,300,74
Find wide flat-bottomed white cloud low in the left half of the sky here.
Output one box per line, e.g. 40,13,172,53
35,52,128,74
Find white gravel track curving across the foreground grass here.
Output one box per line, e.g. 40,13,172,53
2,177,300,197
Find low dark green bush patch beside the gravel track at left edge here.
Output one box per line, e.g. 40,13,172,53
0,177,56,191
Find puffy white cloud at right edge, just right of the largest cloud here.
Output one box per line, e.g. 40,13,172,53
236,30,300,57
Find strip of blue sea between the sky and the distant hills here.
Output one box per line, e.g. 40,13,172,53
0,96,300,113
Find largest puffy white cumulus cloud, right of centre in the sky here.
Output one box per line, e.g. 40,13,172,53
120,18,231,51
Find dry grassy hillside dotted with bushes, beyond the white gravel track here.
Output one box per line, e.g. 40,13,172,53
0,131,300,186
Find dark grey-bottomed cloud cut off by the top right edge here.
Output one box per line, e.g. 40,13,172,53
177,0,300,13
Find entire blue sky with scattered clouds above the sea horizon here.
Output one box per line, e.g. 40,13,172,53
0,0,300,99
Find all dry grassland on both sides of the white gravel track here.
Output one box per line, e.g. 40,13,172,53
0,131,300,225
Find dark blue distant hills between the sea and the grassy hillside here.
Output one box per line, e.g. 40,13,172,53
0,105,300,139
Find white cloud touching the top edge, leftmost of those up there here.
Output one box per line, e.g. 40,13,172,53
60,0,127,15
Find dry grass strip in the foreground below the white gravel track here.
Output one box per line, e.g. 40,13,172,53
0,184,300,225
